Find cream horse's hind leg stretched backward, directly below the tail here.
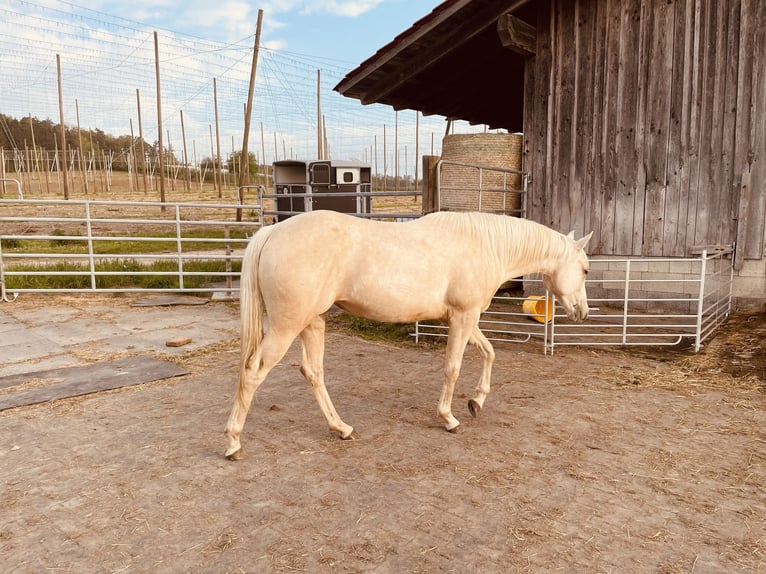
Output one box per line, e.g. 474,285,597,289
224,329,295,460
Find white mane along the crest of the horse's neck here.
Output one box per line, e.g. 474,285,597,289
426,211,571,260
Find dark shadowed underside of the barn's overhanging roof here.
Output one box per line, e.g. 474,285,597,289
334,0,533,131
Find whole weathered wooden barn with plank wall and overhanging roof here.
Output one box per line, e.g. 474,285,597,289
335,0,766,304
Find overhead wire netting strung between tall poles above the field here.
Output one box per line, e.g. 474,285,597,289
0,0,492,173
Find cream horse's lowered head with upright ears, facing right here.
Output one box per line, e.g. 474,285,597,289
543,231,593,321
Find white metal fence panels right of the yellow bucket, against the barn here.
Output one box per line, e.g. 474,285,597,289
549,247,734,352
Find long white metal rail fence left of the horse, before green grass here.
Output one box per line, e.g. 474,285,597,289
0,200,261,301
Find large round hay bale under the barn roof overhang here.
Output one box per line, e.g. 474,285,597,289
439,134,524,216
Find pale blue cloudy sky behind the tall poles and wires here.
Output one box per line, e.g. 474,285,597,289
0,0,498,172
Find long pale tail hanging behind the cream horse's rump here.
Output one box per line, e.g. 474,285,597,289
239,226,274,400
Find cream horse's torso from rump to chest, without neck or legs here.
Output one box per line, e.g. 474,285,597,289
259,211,508,322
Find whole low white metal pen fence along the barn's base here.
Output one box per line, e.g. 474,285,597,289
413,247,734,353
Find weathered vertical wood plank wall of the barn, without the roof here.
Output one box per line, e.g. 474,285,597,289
524,0,766,266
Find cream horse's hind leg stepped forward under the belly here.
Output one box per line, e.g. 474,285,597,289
301,316,355,439
